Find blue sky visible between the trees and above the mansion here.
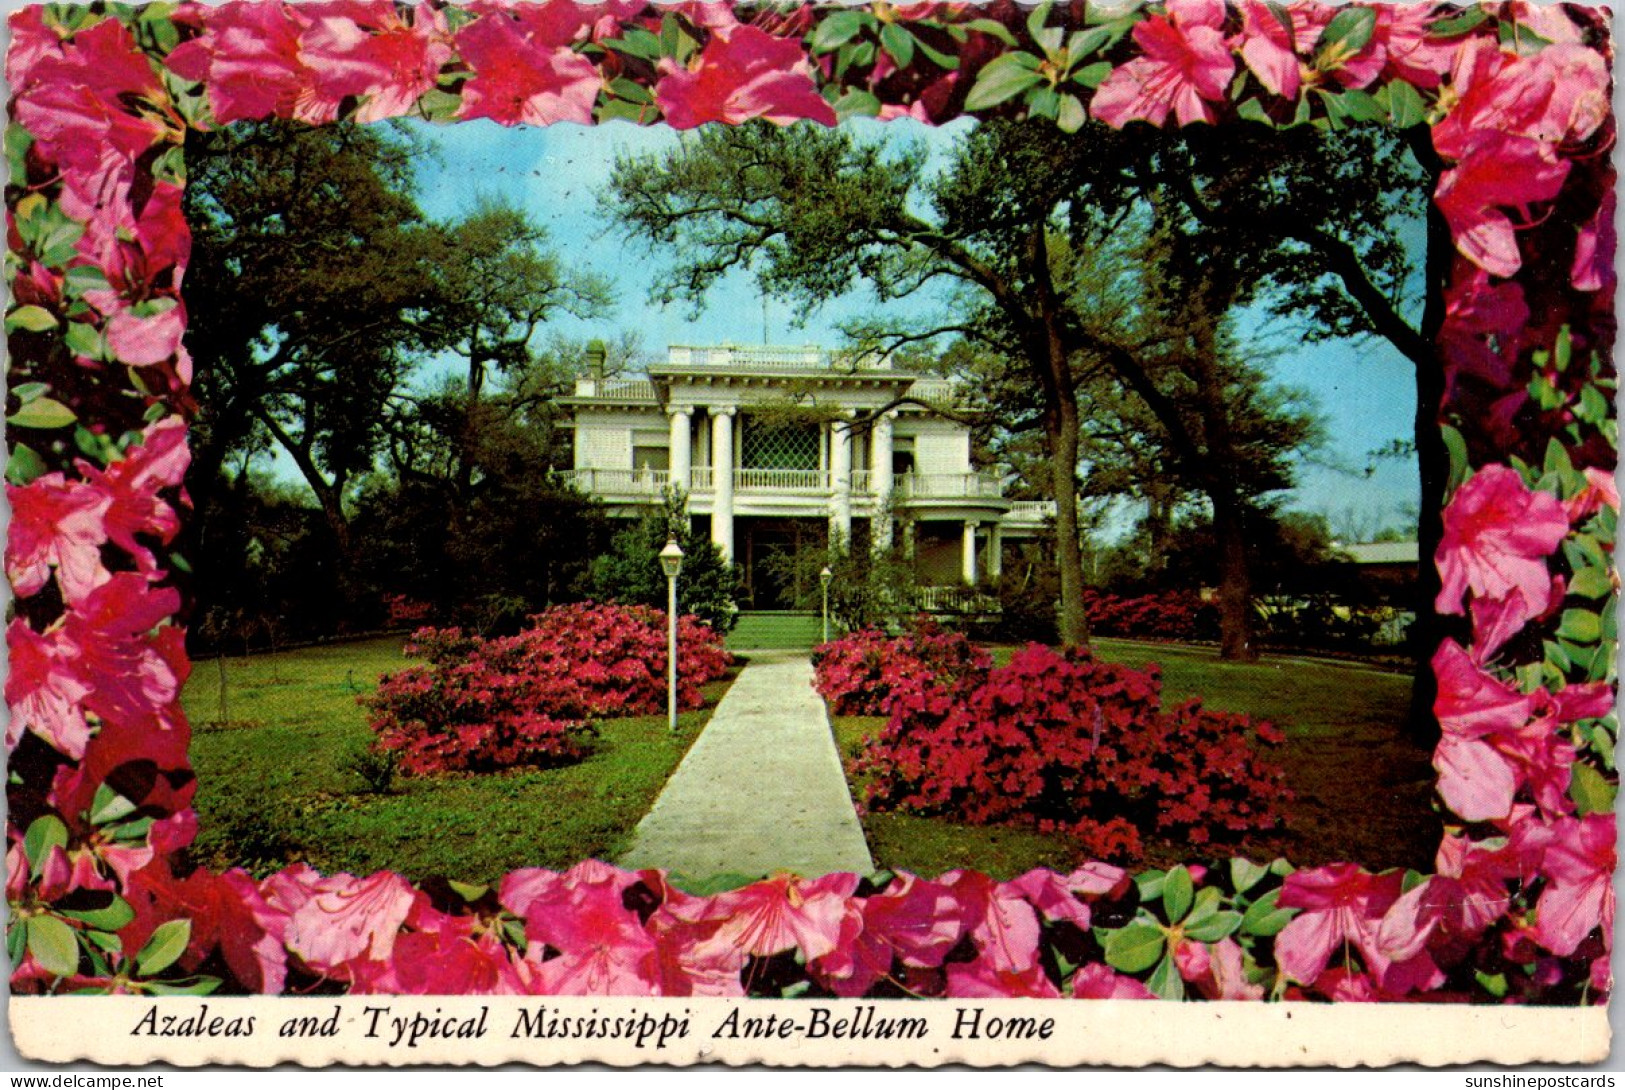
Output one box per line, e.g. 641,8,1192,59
399,120,1417,530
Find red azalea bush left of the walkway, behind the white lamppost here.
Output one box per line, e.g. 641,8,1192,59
362,603,733,775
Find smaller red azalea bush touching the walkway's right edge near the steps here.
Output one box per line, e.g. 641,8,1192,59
813,617,993,715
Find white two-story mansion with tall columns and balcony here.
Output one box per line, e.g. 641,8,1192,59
562,344,1053,609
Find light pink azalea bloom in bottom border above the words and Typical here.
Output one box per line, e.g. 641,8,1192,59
284,871,423,978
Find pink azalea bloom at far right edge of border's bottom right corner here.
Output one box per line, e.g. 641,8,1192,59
1534,814,1619,957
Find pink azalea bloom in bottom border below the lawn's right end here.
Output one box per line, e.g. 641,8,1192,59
1276,863,1404,984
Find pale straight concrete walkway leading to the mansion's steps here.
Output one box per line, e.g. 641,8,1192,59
619,651,874,877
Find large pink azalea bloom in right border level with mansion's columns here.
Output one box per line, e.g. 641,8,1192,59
1435,466,1568,614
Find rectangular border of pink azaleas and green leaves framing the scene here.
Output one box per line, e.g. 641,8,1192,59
5,0,1619,1002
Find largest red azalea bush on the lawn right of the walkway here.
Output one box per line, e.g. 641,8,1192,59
858,643,1289,858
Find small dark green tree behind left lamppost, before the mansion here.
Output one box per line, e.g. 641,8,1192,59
587,489,739,632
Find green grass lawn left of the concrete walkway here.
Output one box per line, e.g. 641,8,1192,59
184,638,736,882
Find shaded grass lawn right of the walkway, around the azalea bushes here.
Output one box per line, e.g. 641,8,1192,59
835,640,1440,877
